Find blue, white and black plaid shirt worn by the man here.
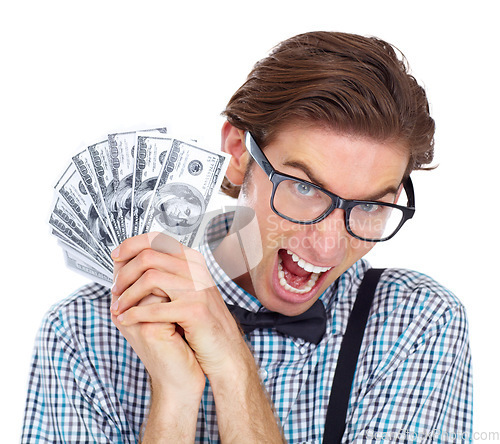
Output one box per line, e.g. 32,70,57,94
22,213,472,444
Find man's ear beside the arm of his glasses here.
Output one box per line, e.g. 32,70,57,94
221,121,249,185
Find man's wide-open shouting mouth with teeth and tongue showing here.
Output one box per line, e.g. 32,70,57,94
278,249,332,295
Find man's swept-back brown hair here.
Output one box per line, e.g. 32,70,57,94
222,32,434,197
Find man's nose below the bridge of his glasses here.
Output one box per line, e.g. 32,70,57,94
307,209,349,259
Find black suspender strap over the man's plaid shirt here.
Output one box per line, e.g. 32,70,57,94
323,268,384,444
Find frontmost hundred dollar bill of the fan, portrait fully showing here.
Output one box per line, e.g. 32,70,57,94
142,139,229,247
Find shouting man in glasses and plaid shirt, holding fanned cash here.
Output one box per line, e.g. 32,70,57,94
24,32,472,443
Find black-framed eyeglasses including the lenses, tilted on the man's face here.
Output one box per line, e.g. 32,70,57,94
245,131,415,242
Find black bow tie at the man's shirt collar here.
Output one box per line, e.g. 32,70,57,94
227,299,326,345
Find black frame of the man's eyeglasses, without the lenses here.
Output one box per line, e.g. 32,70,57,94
245,131,415,242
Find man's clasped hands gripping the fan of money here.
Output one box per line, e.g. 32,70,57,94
111,233,244,397
